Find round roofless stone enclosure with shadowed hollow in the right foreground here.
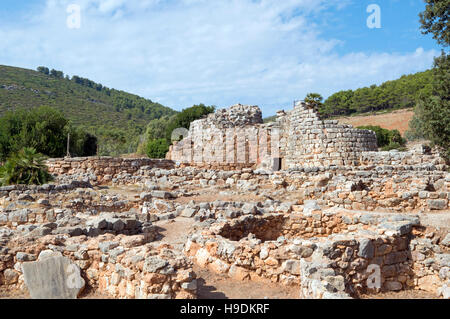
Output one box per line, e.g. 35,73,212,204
185,210,450,299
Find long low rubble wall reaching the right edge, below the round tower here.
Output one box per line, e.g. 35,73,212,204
279,167,450,211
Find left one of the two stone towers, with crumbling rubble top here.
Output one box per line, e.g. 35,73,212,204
167,104,278,170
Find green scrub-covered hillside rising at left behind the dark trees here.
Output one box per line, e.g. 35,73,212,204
0,65,176,155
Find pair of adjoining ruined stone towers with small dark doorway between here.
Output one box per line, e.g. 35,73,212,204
167,103,377,169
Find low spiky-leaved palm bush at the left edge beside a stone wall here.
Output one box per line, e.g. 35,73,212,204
0,147,52,186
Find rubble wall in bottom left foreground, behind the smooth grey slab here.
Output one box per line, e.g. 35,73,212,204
0,235,197,299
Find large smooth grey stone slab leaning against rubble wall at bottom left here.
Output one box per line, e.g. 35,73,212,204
22,256,85,299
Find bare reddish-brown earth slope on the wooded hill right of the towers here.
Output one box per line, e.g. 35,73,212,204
338,109,414,136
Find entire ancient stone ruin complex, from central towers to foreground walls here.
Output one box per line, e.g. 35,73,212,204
0,102,450,299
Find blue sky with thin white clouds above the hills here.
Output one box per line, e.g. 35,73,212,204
0,0,440,116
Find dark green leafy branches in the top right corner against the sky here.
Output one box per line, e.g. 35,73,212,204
419,0,450,47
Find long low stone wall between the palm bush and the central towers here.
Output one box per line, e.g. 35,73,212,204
46,157,175,183
